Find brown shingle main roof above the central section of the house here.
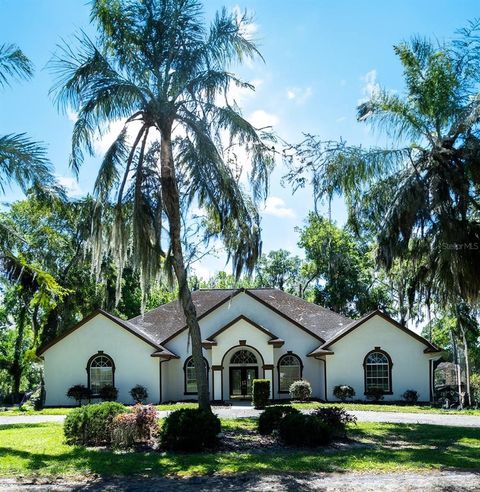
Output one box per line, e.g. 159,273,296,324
129,289,352,344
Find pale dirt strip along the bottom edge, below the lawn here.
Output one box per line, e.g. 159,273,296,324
0,471,480,492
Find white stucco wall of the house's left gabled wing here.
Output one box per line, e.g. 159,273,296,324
43,314,159,406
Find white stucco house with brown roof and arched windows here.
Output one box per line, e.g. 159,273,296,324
39,289,440,406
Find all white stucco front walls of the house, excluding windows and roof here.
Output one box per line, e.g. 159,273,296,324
43,293,433,406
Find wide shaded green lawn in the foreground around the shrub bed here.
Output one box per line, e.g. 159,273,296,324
0,419,480,477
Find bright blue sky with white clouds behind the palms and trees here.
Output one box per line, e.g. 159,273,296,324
0,0,480,274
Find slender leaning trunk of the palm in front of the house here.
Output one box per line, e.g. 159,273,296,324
160,125,211,411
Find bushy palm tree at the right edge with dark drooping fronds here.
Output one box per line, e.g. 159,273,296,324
289,23,480,305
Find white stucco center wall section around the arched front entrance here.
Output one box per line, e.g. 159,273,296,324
162,293,324,401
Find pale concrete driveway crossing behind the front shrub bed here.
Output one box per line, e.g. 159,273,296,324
0,405,480,427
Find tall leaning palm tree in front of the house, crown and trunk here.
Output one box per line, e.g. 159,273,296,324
52,0,273,409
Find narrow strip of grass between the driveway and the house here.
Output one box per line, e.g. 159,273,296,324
0,401,480,416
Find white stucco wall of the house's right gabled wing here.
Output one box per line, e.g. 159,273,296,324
325,316,430,401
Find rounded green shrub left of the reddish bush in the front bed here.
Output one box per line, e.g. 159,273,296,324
63,402,127,445
